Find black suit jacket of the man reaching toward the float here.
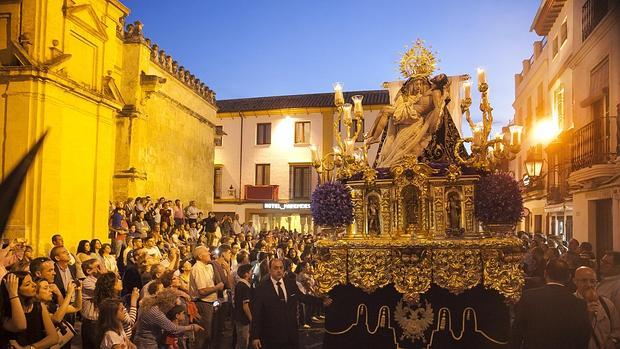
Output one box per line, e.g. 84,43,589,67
250,277,321,348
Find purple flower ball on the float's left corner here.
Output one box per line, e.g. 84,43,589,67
310,181,353,227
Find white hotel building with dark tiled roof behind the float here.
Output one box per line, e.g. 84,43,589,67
214,90,389,232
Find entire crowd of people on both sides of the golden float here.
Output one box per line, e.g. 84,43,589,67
0,196,620,349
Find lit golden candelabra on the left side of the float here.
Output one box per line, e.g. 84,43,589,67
310,82,374,183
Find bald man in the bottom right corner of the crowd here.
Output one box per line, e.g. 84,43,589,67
573,267,620,348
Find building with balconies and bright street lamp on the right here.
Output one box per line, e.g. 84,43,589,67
510,0,620,253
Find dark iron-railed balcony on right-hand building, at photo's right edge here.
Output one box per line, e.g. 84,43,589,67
571,116,617,172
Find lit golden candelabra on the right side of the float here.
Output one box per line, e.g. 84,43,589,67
454,69,523,170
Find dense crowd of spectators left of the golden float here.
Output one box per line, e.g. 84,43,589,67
0,196,331,349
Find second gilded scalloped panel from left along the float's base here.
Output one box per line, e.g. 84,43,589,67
347,248,392,293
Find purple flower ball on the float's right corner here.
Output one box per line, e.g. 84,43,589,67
475,173,523,224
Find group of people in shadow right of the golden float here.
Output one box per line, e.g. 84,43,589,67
510,233,620,349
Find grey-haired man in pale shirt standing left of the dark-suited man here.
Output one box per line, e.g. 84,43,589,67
189,246,224,349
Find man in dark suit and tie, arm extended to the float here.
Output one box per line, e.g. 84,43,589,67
250,259,331,349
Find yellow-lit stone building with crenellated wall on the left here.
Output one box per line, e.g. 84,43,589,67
0,0,217,252
